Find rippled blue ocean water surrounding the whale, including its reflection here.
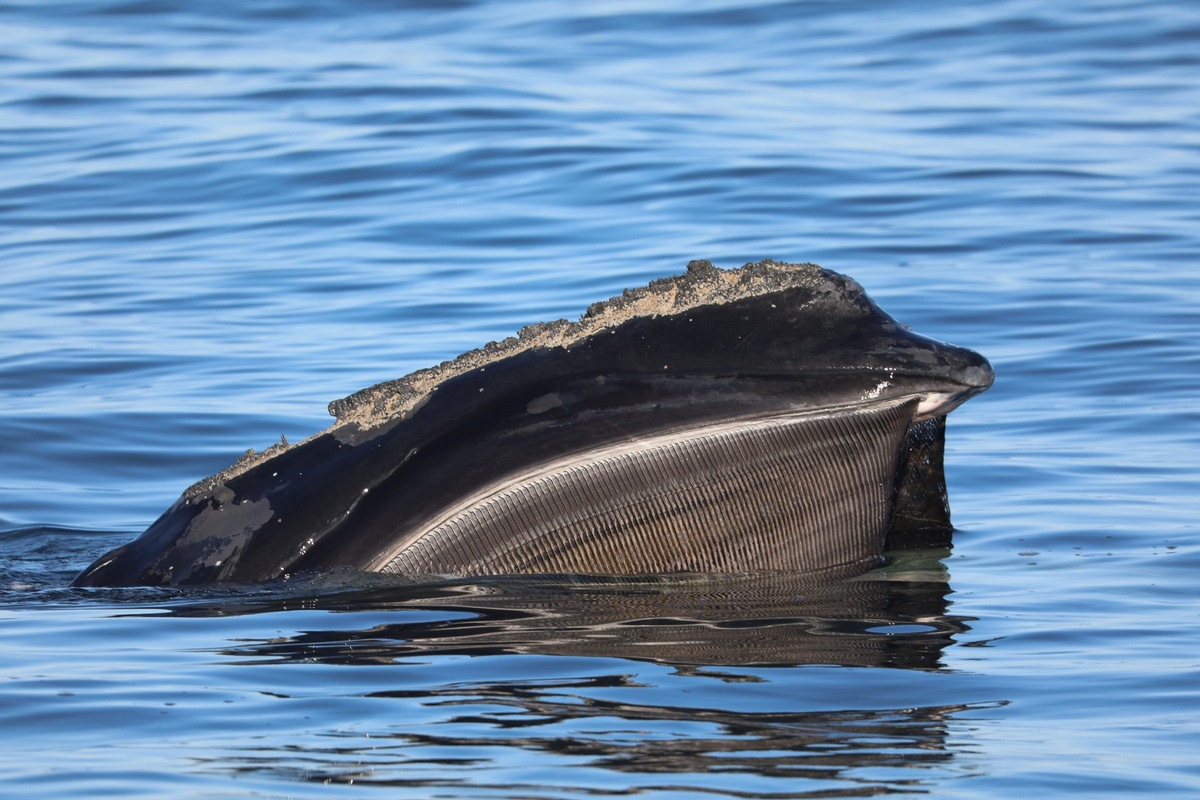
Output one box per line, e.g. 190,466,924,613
0,0,1200,800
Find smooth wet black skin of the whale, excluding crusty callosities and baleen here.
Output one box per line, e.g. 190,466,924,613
74,272,992,587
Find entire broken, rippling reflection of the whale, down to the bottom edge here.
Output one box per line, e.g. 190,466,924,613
187,551,996,798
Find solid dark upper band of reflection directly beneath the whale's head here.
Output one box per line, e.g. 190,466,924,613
152,549,968,670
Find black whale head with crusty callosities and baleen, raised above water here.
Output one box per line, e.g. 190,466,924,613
73,260,994,587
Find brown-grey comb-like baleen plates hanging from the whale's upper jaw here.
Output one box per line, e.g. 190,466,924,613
371,401,917,575
